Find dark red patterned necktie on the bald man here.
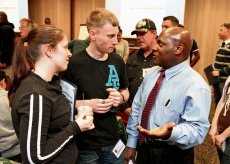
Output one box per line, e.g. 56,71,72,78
138,70,165,145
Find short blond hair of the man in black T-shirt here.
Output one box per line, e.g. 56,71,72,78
86,8,119,31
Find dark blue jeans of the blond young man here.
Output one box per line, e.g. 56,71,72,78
76,145,125,164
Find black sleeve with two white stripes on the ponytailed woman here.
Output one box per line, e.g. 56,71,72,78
17,94,80,163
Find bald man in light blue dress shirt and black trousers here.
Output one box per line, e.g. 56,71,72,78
125,27,211,164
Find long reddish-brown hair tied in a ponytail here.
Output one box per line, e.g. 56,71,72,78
9,25,64,104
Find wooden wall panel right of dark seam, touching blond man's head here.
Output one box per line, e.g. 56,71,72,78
72,0,105,39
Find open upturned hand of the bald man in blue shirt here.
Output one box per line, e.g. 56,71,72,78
137,122,176,139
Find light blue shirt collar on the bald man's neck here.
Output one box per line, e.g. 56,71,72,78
165,60,189,81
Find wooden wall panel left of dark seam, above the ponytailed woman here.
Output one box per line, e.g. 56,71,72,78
28,0,71,39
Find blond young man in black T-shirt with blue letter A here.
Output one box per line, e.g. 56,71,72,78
61,9,129,164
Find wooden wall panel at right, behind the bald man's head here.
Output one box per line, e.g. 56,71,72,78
184,0,230,78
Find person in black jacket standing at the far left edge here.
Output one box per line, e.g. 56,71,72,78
0,11,15,69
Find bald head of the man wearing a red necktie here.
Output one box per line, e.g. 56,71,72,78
155,27,192,69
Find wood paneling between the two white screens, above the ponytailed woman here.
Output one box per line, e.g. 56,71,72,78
28,0,105,39
